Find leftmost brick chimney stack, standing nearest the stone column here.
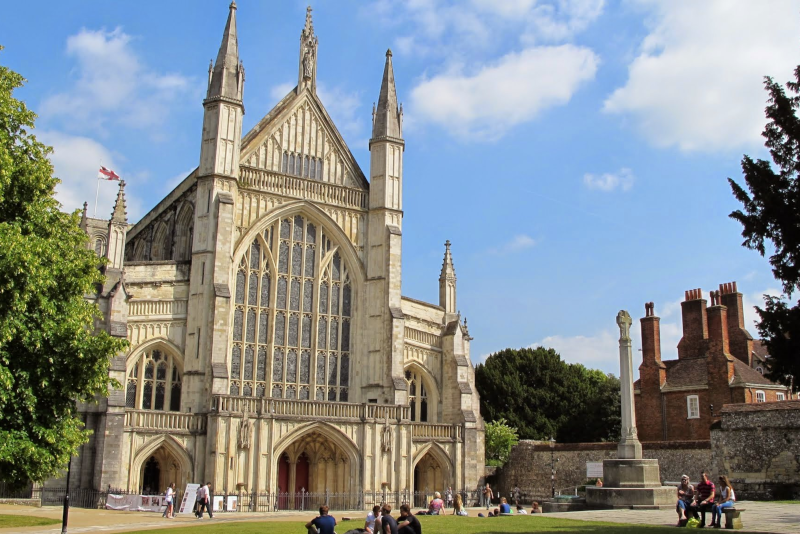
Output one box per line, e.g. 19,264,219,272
635,302,667,441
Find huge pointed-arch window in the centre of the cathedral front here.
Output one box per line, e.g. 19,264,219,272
230,215,353,402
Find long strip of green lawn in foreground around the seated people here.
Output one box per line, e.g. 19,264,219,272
122,514,692,534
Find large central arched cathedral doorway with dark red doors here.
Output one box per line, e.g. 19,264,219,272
276,430,357,510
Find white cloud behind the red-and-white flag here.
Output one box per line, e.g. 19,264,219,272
37,131,141,221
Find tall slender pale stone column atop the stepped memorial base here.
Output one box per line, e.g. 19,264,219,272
617,310,642,460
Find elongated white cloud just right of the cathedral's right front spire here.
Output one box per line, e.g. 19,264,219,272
410,45,599,140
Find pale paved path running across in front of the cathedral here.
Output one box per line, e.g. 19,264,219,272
0,501,800,534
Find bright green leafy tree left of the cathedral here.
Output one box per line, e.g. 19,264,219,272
0,51,125,485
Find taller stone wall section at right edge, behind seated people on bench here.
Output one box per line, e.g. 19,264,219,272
711,400,800,499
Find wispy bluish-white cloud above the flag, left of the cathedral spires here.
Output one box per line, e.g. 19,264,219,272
41,28,190,135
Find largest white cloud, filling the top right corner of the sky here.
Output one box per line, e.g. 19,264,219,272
604,0,800,151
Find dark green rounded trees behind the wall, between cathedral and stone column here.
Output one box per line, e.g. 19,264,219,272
475,347,620,443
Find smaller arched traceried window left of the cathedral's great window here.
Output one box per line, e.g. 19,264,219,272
125,349,183,412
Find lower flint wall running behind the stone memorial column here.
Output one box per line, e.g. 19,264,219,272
489,440,712,502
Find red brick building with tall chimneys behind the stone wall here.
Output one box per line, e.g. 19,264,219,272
634,282,791,441
